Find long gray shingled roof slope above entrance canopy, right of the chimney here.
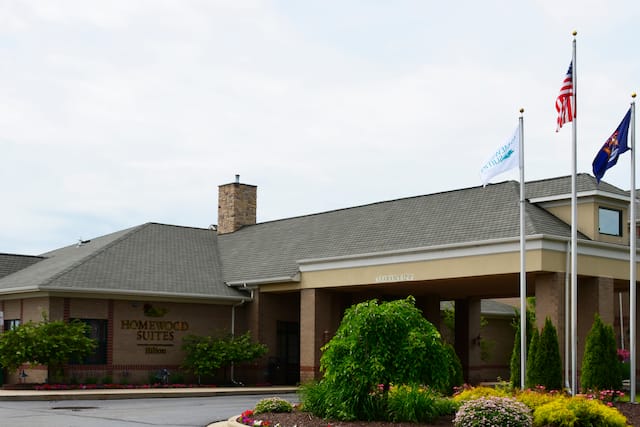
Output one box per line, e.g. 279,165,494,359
218,181,585,282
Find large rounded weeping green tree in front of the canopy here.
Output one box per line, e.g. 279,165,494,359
303,297,460,420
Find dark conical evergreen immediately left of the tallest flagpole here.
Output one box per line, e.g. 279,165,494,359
535,317,562,390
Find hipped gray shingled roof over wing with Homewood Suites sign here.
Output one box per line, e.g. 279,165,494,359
0,223,247,301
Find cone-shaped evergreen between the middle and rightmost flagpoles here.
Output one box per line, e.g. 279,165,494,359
580,313,622,391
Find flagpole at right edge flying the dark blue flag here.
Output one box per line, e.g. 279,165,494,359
629,93,637,403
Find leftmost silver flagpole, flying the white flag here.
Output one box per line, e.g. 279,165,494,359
518,108,527,390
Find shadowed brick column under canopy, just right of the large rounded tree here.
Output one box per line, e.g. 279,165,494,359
455,298,482,384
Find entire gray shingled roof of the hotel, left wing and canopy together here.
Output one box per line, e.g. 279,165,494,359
5,174,628,294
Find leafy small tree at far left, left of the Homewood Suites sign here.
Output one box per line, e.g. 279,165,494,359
0,316,97,379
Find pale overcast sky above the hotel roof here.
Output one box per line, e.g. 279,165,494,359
0,0,640,254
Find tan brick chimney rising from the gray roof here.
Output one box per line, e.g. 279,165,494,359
218,175,258,234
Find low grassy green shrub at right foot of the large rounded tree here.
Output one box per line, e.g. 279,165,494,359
387,385,459,423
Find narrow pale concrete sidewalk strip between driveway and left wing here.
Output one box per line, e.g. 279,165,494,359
0,386,298,401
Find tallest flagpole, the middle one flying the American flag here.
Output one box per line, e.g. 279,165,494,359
571,31,578,396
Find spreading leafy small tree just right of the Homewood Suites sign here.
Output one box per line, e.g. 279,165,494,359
182,331,267,377
